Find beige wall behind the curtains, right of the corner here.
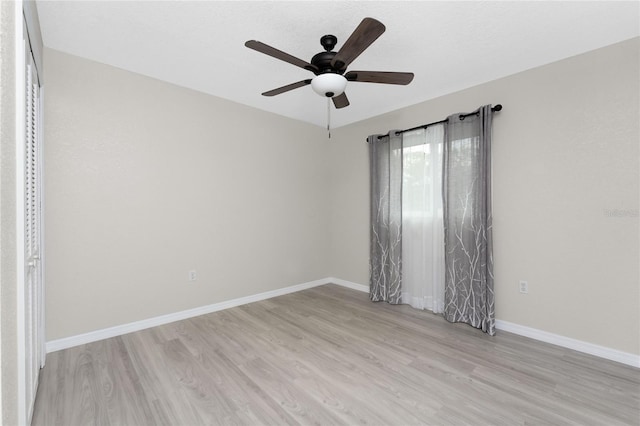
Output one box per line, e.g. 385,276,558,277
329,38,640,354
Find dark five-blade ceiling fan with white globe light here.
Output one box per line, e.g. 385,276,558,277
244,18,413,108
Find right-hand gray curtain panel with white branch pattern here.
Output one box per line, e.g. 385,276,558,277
442,105,495,335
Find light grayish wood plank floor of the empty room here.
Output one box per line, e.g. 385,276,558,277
32,285,640,426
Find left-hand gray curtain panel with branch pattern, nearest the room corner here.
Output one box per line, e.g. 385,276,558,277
368,131,402,304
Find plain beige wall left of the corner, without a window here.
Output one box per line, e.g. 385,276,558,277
45,49,329,340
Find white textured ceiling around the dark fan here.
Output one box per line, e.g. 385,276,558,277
37,0,640,127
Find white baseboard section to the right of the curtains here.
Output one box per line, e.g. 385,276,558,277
496,320,640,368
